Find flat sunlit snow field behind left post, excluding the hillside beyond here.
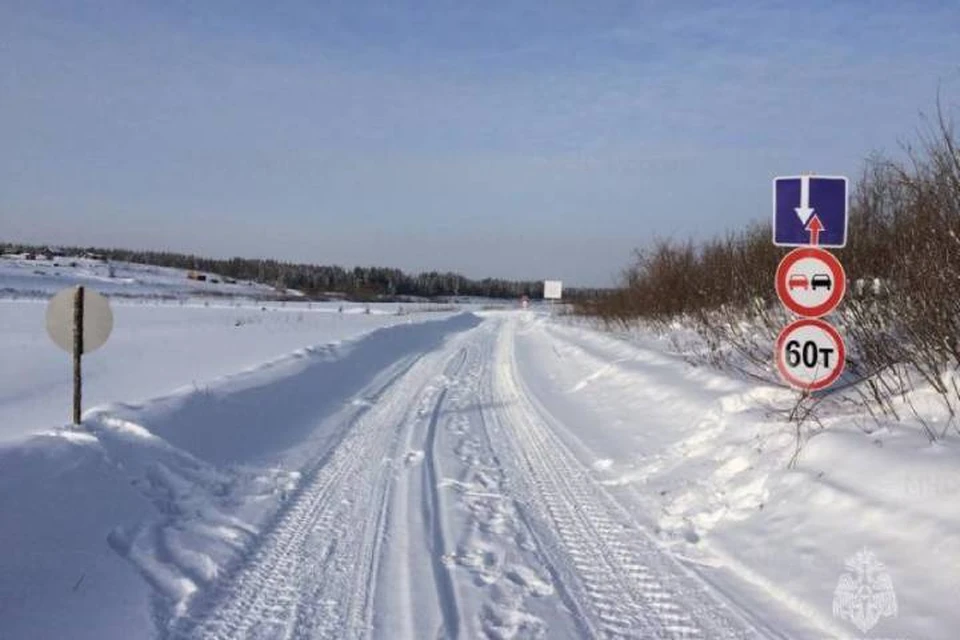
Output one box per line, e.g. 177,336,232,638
0,299,444,442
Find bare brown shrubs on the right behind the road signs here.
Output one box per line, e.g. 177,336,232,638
576,102,960,440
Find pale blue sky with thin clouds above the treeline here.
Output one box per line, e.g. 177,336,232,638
0,0,960,285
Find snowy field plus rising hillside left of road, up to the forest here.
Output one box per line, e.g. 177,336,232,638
0,252,458,442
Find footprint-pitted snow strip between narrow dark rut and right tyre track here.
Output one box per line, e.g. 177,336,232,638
422,332,583,640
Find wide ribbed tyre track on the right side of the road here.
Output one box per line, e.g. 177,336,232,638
491,320,757,640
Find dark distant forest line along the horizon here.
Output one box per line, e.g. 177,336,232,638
0,242,599,300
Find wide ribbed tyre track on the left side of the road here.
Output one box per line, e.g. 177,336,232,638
168,336,476,640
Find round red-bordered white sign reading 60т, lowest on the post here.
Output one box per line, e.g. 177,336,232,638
776,318,846,391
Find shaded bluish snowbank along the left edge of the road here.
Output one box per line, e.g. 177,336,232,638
0,314,477,638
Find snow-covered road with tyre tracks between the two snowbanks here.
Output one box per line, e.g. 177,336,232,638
161,314,770,639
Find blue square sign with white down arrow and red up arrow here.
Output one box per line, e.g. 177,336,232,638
773,176,847,248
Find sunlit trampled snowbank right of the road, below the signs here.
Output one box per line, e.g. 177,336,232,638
532,319,960,640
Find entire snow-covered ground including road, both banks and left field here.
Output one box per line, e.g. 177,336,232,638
0,258,960,640
